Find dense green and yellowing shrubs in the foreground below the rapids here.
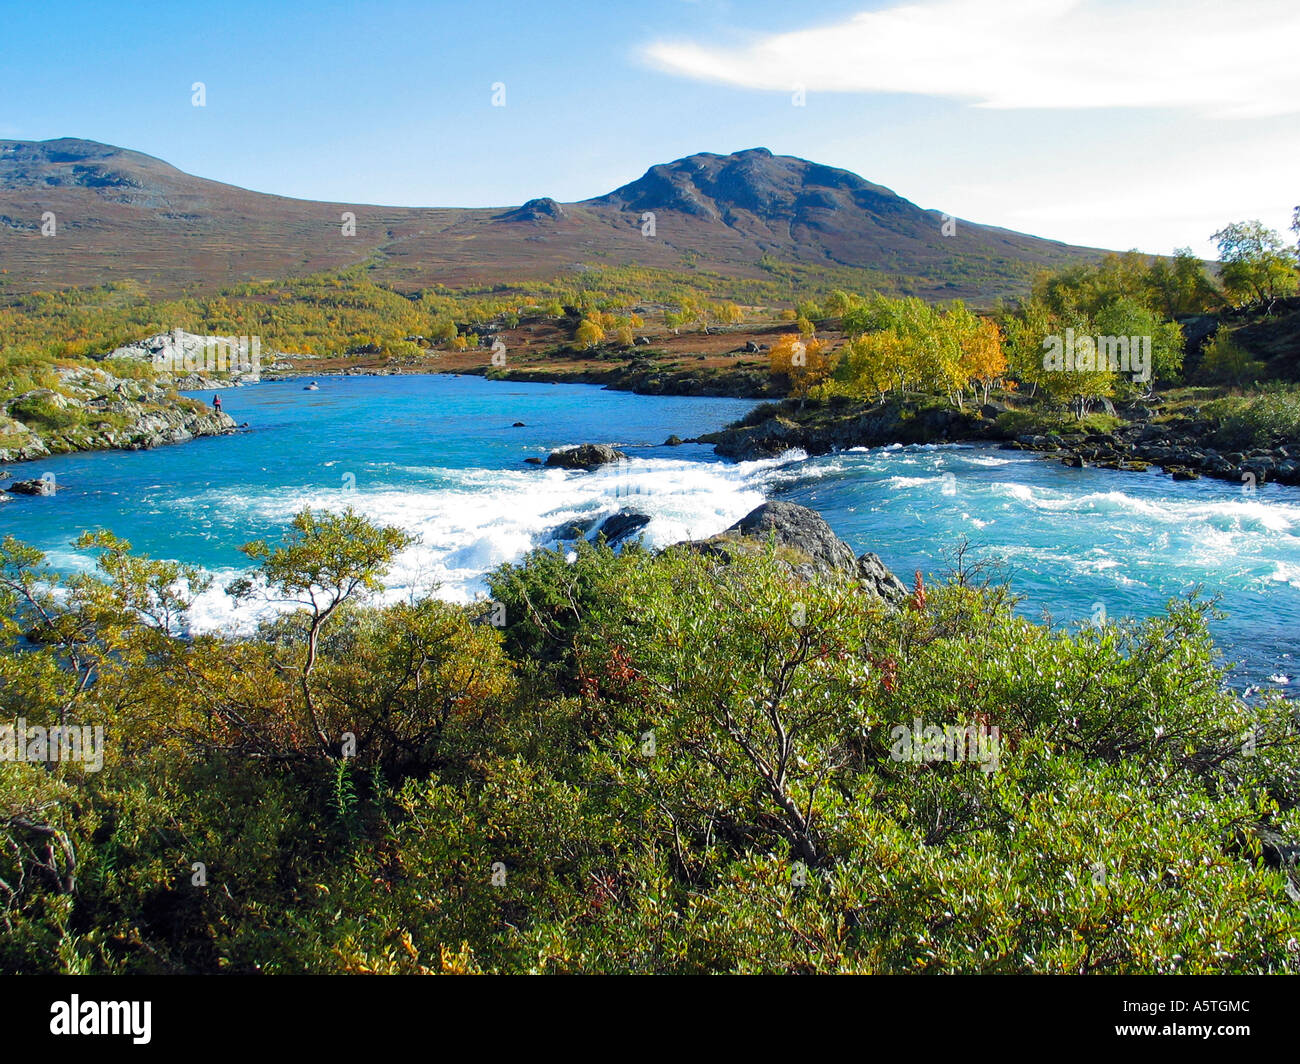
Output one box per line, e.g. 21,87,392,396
0,512,1300,973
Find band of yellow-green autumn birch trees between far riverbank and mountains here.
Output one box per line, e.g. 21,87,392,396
0,221,1300,432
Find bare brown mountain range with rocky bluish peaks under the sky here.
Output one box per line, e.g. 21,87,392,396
0,139,1099,302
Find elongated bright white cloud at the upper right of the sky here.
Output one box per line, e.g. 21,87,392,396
645,0,1300,118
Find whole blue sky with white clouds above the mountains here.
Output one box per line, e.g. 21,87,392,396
0,0,1300,254
